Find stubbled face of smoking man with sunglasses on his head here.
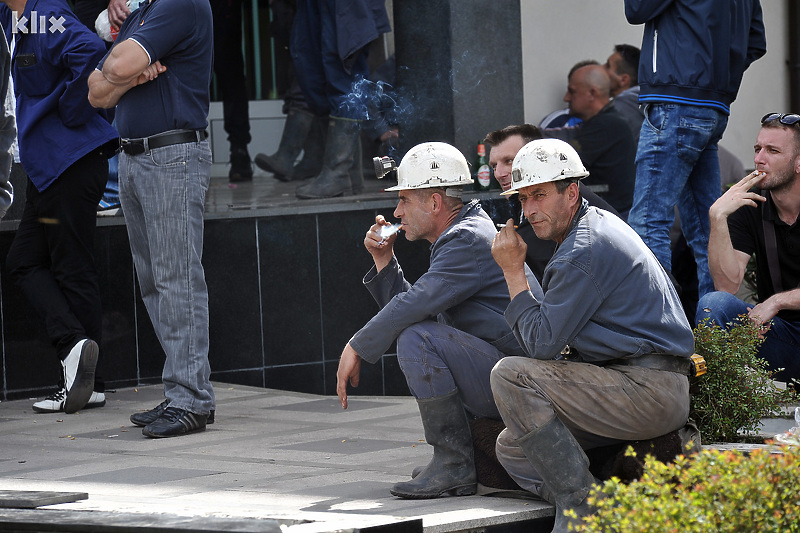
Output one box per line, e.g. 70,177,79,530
753,126,800,191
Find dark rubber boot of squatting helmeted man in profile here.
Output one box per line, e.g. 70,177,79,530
390,391,478,499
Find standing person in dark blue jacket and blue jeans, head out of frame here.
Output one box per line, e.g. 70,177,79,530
625,0,767,297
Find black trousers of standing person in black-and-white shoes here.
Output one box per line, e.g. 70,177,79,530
7,148,108,392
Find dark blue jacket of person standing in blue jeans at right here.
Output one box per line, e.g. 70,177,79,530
625,0,767,114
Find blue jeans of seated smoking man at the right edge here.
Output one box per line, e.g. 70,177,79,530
696,291,800,382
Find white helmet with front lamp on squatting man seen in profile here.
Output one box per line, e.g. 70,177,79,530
386,142,472,191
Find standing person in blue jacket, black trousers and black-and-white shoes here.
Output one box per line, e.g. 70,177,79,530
0,0,117,413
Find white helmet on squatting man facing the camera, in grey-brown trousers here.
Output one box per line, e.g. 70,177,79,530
502,139,589,196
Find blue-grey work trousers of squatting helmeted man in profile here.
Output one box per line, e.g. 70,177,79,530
397,321,506,420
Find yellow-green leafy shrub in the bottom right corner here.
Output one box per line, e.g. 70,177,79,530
577,447,800,533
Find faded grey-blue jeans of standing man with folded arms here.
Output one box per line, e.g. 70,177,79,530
119,141,214,415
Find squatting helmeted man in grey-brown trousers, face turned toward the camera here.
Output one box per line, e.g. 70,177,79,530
491,139,694,532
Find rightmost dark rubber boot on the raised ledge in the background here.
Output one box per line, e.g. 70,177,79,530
296,117,358,199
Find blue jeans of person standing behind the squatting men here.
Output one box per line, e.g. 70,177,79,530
628,104,728,296
